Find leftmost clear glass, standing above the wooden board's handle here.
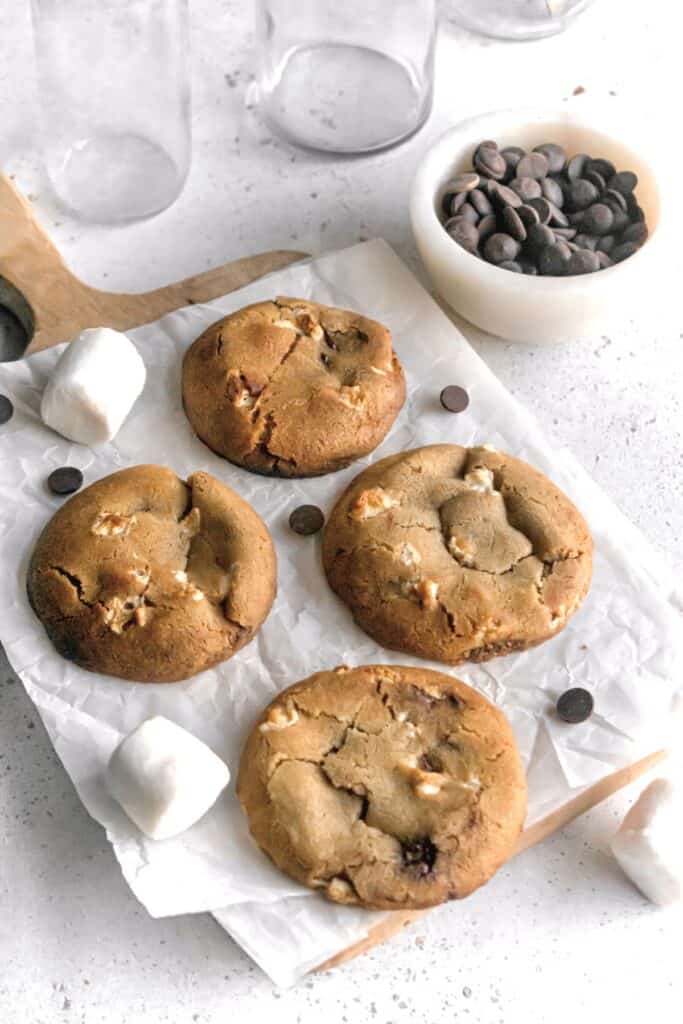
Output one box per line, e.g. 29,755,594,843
32,0,190,223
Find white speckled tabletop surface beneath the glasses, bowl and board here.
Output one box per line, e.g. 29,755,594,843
0,0,683,1024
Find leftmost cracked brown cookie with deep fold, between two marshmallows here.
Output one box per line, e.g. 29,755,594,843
28,466,276,683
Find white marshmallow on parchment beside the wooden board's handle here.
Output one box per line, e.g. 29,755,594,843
40,327,145,444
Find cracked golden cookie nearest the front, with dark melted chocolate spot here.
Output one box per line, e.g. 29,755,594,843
238,666,526,909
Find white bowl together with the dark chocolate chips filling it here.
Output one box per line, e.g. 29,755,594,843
411,112,661,344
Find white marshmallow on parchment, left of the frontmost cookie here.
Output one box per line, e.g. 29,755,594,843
105,715,230,839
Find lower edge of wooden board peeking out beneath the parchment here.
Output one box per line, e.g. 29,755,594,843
313,751,667,973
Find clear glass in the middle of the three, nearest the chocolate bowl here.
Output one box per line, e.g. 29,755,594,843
256,0,436,154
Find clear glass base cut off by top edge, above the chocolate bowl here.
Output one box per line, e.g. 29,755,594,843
445,0,593,39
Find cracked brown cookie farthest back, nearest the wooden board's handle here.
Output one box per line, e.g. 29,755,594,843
182,298,405,476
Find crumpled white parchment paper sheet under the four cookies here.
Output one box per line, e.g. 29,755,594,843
0,241,683,984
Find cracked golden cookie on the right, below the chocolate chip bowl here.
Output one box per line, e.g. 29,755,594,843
323,444,593,665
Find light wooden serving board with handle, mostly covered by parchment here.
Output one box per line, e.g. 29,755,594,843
0,175,667,971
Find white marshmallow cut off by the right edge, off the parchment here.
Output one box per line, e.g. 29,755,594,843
611,778,683,905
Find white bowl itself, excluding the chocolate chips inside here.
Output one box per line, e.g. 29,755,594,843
411,111,661,344
